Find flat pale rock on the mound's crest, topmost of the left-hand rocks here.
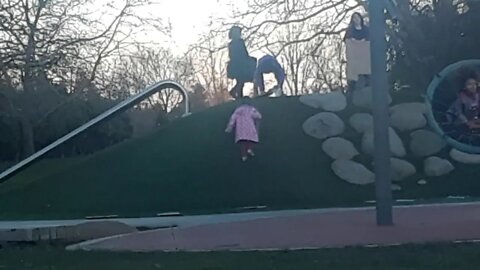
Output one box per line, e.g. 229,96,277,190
300,91,347,112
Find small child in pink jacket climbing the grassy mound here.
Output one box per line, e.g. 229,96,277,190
225,98,262,161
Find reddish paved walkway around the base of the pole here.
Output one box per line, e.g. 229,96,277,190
68,203,480,252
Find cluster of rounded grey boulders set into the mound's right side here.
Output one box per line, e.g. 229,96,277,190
300,88,474,190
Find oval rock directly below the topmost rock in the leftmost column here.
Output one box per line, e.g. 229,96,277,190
303,112,345,139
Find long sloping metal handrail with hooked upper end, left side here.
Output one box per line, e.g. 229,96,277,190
0,80,190,183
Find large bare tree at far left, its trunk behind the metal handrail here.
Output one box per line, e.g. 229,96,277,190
0,0,169,155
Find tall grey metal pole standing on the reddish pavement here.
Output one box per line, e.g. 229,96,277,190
368,0,393,226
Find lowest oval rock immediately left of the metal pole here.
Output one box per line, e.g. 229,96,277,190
332,160,375,185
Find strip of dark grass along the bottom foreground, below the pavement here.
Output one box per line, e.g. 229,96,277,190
0,244,480,270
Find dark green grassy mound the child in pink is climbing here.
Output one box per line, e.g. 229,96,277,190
0,98,480,219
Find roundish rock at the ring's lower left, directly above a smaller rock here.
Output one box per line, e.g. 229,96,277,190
410,130,446,157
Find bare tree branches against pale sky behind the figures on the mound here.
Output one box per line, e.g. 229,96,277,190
185,0,364,95
